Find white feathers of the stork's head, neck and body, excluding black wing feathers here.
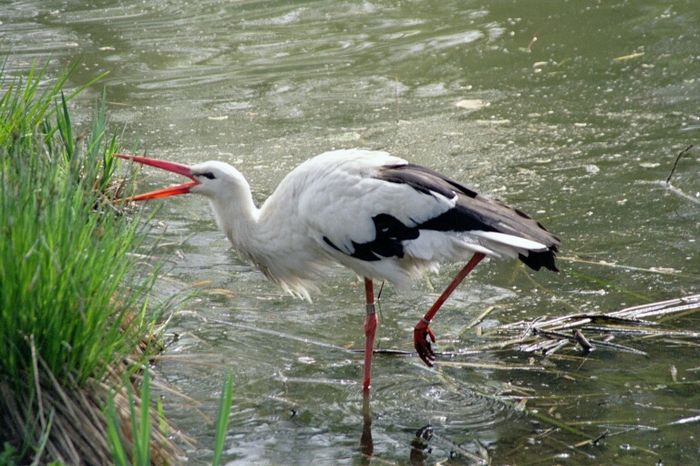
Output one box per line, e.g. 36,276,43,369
183,149,547,299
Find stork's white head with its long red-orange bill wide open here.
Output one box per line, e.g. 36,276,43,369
115,154,250,201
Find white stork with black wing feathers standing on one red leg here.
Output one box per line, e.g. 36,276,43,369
117,149,559,392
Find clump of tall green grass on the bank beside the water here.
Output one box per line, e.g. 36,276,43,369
0,63,178,464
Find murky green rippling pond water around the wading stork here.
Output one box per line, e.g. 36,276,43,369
0,0,700,465
